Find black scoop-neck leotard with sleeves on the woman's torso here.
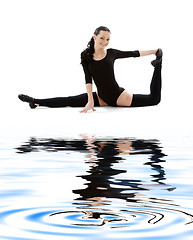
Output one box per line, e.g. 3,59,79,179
82,48,140,106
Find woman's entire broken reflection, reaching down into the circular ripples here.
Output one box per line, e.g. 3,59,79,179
17,135,192,228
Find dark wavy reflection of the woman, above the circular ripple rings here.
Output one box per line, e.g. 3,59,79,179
17,136,171,193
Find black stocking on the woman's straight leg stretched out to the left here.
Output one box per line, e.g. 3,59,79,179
34,92,100,108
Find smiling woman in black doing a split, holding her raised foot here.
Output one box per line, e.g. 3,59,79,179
18,26,163,113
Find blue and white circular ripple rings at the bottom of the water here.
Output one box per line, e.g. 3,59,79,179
0,202,193,239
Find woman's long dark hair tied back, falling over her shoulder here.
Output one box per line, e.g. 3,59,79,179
81,26,111,63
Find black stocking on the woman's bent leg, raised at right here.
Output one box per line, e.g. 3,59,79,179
130,63,162,107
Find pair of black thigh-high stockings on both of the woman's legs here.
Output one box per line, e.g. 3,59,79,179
34,64,161,108
